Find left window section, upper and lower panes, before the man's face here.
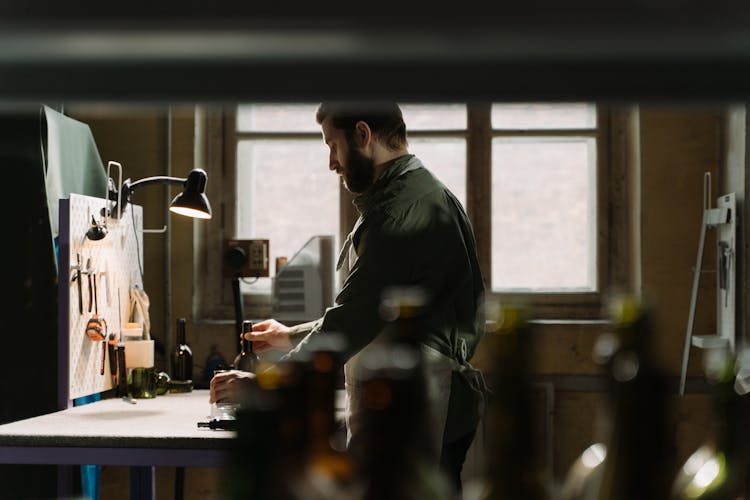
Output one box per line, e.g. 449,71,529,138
235,104,340,294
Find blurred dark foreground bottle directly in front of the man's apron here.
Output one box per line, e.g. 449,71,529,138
347,287,454,500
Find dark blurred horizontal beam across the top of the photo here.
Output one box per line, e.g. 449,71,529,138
0,0,750,102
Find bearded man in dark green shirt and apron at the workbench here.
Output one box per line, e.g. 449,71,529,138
211,103,485,491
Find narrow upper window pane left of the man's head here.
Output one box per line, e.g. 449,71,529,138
237,103,320,132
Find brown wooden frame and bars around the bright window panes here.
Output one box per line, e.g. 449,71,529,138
198,102,629,320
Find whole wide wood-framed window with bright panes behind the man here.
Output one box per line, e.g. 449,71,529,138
200,103,607,317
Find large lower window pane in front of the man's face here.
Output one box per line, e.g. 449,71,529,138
237,140,340,291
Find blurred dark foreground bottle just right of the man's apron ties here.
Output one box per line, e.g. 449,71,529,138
481,301,550,500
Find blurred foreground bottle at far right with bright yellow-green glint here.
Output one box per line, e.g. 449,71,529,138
672,349,750,500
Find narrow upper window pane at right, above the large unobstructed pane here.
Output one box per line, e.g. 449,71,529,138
492,103,596,130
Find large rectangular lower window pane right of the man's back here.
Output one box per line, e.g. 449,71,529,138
492,138,596,291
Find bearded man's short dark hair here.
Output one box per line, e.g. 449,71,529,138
315,102,408,150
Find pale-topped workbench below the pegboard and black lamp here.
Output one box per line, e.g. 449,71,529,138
0,390,235,499
